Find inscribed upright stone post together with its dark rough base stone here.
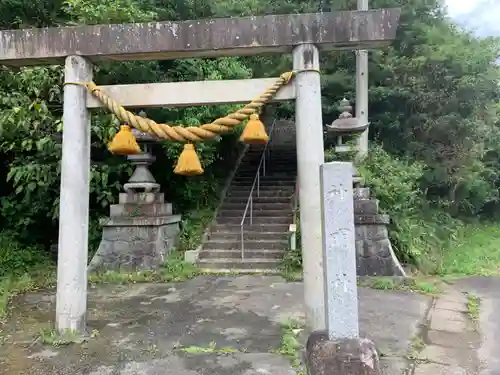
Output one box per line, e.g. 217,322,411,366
306,162,380,375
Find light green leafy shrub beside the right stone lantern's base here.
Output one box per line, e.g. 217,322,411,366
358,145,461,272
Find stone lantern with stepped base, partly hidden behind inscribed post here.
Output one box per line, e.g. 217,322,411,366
326,99,406,276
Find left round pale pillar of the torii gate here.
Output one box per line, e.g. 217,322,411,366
56,56,92,332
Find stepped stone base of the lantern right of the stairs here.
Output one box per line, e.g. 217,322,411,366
354,187,406,276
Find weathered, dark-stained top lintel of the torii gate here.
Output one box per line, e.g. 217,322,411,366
0,9,401,66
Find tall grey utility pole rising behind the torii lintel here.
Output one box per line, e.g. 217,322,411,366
356,0,369,157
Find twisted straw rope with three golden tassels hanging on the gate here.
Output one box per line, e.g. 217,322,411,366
65,72,296,176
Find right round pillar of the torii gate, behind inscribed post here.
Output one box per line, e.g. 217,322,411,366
293,44,326,329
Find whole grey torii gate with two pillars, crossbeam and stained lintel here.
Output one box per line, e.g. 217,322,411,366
0,9,400,331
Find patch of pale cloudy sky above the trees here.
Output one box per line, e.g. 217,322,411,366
445,0,500,36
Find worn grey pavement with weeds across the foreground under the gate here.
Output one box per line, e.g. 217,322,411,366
0,276,500,375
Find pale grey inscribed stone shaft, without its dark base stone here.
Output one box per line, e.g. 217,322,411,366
320,162,359,340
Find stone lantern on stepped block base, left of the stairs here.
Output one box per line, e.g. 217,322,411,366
88,113,181,272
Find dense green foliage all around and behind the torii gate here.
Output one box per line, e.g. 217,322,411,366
0,0,500,276
